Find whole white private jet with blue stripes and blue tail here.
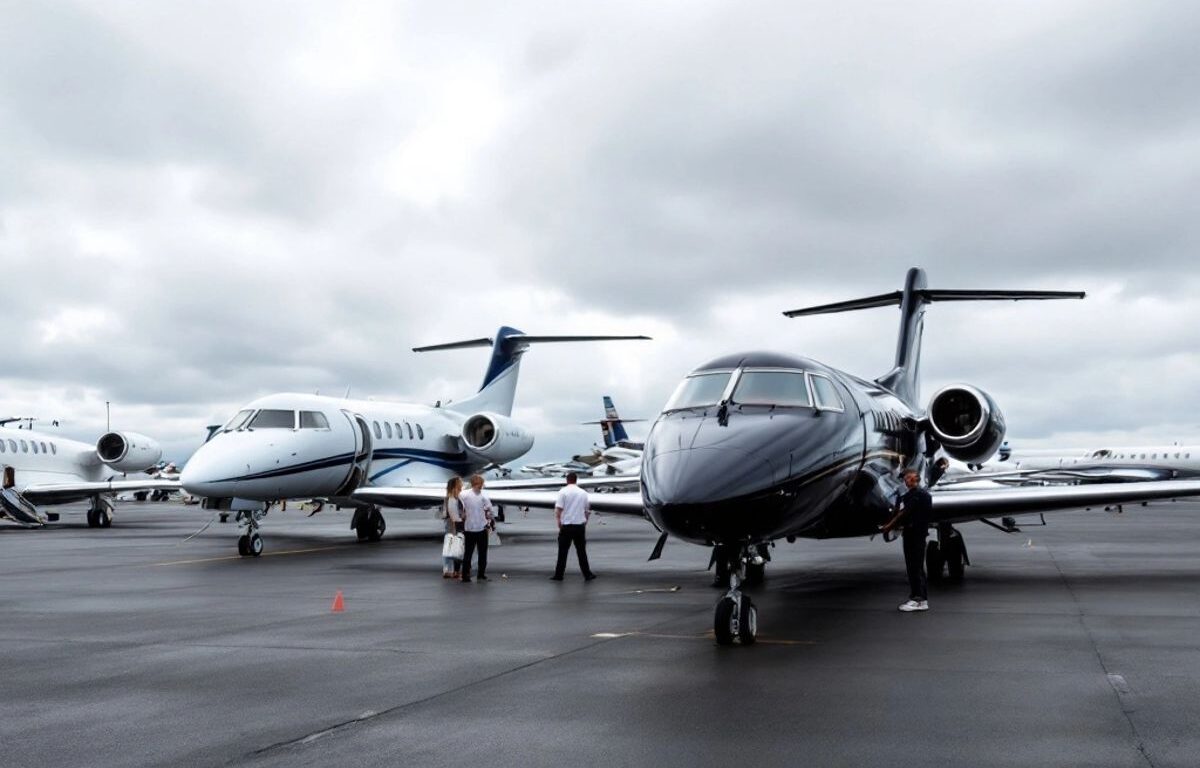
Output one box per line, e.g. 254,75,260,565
180,326,648,556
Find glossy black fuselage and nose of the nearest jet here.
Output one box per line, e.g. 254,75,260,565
642,353,922,545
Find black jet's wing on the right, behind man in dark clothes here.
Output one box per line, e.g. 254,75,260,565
932,480,1200,522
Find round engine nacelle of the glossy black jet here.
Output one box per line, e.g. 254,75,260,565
929,384,1004,462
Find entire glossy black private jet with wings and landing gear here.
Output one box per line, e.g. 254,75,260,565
355,269,1200,644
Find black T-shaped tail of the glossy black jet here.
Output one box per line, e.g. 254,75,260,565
784,266,1086,408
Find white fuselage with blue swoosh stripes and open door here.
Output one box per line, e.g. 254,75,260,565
180,394,516,500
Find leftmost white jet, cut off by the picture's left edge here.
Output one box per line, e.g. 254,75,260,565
0,420,179,528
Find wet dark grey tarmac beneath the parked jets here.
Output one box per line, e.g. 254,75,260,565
0,494,1200,768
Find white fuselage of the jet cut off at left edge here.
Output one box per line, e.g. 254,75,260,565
0,427,114,491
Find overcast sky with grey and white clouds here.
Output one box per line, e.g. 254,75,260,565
0,0,1200,461
